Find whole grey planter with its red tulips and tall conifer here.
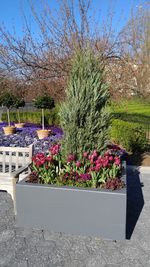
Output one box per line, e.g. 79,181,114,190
16,50,127,239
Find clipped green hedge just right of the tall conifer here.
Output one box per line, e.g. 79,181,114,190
111,119,147,152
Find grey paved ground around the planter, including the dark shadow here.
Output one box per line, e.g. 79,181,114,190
0,171,150,267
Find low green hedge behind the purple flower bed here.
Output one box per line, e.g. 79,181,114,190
2,106,60,125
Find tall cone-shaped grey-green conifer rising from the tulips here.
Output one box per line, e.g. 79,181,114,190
60,50,110,159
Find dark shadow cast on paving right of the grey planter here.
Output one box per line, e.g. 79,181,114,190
126,170,144,239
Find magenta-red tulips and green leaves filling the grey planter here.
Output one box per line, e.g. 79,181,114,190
28,144,124,190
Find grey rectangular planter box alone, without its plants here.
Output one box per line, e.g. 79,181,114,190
16,163,127,240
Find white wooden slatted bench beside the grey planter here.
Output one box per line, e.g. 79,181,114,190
0,145,33,214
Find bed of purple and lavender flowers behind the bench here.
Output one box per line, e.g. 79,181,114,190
0,122,63,154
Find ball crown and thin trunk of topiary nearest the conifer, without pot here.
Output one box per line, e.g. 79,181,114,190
34,95,55,130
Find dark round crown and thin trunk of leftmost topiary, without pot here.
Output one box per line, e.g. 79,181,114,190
0,92,16,126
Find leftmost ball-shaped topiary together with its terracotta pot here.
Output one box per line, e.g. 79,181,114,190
0,92,16,135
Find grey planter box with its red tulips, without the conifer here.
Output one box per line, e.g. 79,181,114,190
16,144,127,240
